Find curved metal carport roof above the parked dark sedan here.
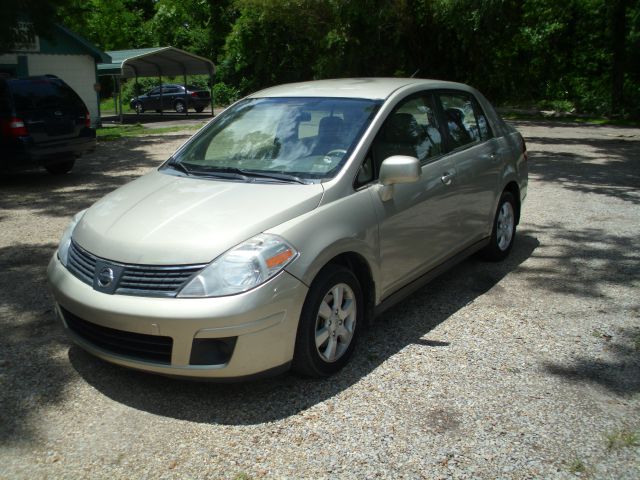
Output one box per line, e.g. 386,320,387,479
98,47,216,78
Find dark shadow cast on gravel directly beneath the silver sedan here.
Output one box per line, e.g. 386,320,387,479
69,235,539,425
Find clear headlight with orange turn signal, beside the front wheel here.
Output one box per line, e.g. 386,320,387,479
178,233,298,297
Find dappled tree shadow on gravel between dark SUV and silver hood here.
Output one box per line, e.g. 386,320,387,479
0,134,189,217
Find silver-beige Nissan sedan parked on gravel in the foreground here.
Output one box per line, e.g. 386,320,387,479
43,78,527,379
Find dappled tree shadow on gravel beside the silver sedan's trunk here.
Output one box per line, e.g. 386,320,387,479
526,137,640,204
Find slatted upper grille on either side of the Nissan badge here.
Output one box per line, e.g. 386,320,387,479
68,241,206,297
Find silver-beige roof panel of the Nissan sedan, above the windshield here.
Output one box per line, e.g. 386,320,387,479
249,78,469,100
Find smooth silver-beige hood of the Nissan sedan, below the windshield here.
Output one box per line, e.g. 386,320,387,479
73,171,323,265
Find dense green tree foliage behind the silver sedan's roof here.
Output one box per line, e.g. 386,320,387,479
46,0,640,117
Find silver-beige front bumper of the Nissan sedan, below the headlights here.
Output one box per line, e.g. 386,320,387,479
47,253,307,379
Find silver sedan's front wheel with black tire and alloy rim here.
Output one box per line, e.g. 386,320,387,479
292,265,364,378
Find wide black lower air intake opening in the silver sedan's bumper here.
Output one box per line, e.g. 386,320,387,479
60,307,173,365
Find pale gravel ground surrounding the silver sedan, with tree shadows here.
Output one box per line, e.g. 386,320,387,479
0,122,640,480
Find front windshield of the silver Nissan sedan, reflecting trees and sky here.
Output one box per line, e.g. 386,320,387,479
172,98,381,180
